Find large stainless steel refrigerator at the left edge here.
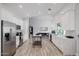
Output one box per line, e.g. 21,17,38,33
1,20,16,56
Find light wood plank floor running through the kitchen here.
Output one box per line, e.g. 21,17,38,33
14,39,63,56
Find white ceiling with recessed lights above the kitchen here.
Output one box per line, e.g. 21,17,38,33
2,3,67,18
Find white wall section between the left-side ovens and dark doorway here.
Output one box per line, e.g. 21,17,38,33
23,17,29,41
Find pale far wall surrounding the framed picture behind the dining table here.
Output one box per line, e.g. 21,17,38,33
30,16,54,35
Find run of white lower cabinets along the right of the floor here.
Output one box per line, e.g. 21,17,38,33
52,35,76,56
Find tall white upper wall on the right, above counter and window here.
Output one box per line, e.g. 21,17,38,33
54,4,75,30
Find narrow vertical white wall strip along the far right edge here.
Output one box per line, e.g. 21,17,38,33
75,4,79,56
